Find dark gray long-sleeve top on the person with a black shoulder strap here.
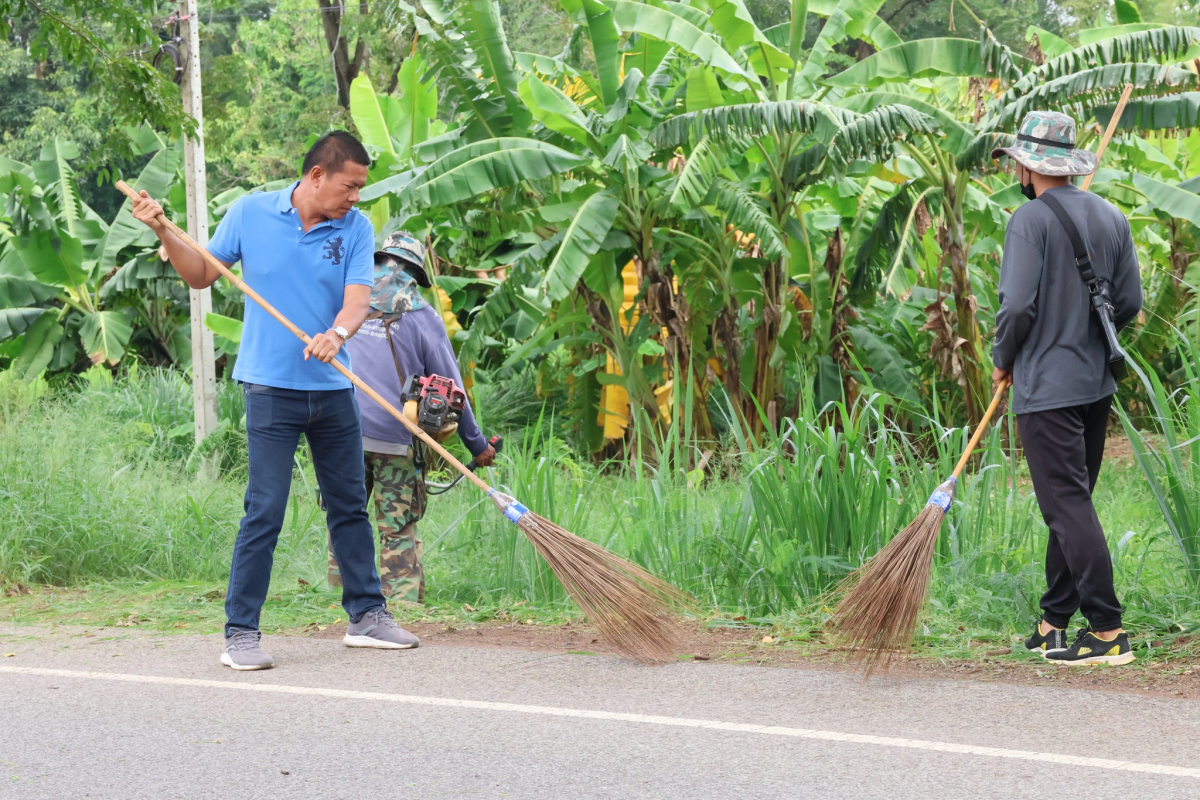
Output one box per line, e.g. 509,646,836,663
991,186,1141,414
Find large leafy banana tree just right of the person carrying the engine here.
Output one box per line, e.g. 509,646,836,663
372,0,768,432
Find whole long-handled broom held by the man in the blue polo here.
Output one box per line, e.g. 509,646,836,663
116,181,686,663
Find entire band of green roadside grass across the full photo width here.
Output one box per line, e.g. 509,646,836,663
0,371,1200,656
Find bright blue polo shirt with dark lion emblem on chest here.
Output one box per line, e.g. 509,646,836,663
209,181,374,391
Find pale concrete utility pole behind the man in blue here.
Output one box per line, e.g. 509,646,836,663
180,0,217,444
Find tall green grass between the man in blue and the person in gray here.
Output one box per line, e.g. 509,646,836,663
430,381,1042,616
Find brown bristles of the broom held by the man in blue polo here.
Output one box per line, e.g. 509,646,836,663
491,491,688,663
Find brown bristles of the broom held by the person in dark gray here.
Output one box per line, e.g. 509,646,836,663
829,477,956,675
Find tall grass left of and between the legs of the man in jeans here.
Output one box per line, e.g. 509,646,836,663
0,371,323,584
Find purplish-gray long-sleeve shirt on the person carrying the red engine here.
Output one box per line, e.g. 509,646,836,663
346,306,487,456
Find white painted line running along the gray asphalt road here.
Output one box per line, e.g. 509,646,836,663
0,667,1200,778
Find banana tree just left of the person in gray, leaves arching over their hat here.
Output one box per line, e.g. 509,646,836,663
826,28,1200,421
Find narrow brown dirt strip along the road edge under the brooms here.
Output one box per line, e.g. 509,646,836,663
308,622,1200,699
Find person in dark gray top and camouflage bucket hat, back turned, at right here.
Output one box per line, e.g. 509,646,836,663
991,112,1142,666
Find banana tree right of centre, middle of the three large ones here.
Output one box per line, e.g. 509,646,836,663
654,0,938,427
